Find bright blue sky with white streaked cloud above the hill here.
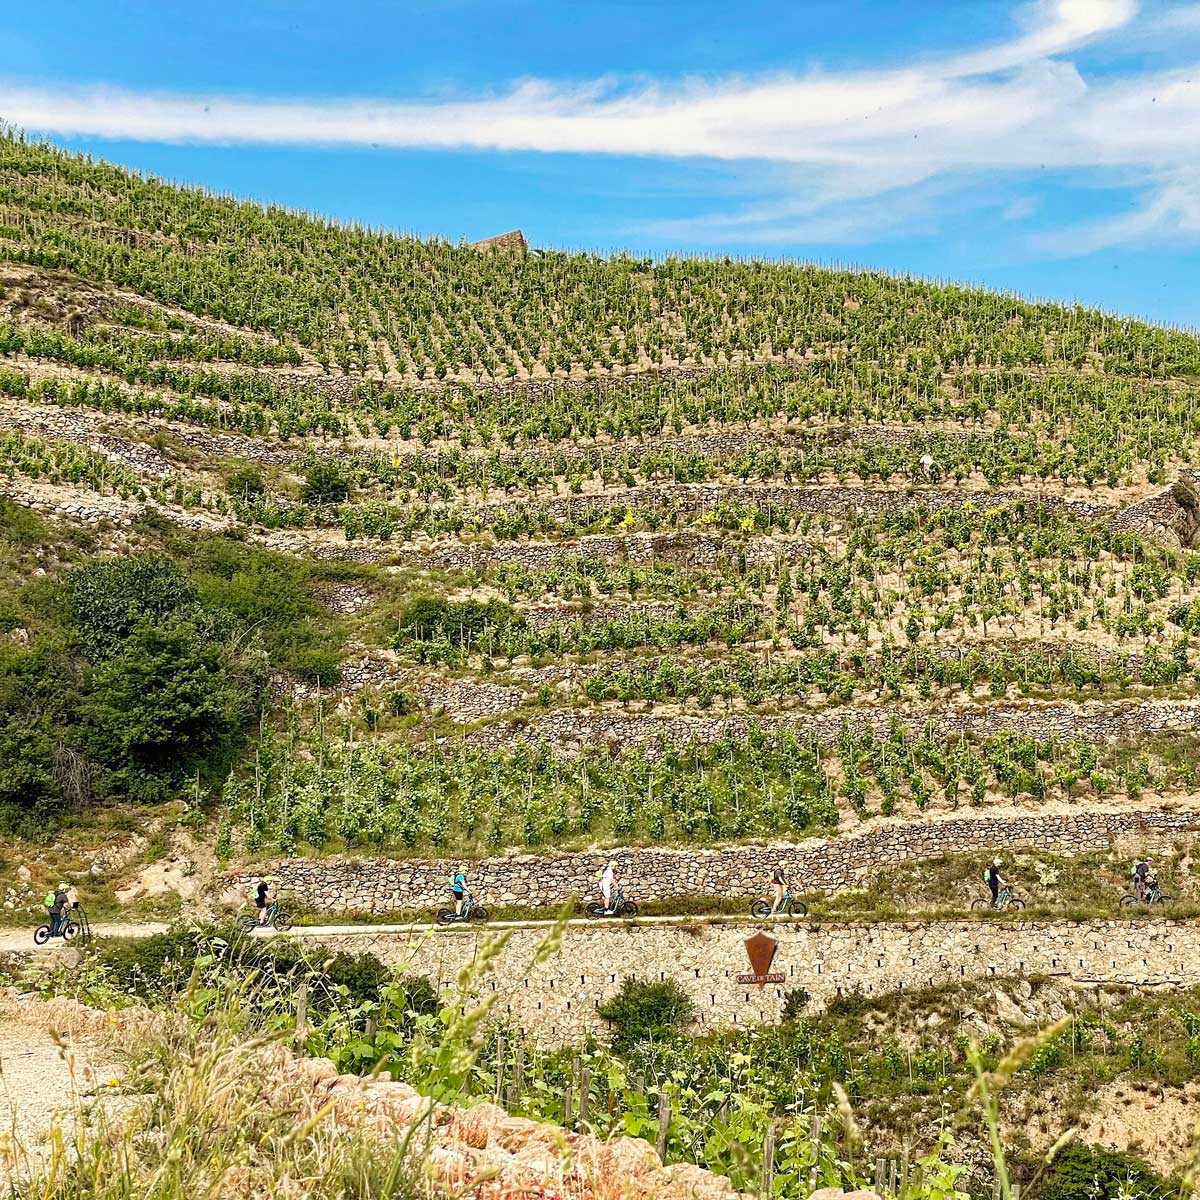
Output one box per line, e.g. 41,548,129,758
0,0,1200,325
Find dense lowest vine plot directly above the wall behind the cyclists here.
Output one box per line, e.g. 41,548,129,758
224,714,835,852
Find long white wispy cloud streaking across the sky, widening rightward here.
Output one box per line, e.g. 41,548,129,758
0,0,1200,253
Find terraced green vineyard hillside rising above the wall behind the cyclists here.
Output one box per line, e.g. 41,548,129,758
0,133,1200,873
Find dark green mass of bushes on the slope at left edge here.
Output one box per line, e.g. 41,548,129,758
0,532,338,838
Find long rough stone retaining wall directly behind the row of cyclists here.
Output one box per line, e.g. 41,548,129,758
228,809,1200,913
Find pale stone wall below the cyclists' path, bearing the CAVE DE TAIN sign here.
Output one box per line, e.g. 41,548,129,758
304,919,1200,1044
